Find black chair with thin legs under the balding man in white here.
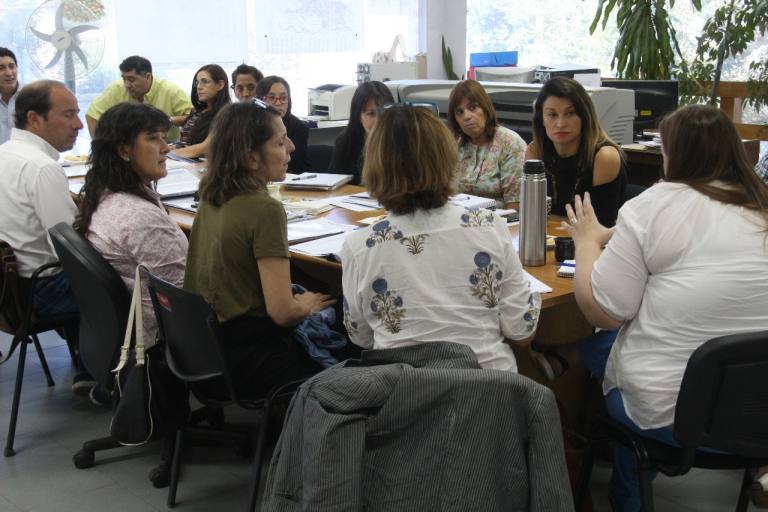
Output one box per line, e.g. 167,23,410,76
0,240,79,457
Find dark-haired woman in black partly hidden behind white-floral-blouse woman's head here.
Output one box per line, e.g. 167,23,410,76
329,81,395,185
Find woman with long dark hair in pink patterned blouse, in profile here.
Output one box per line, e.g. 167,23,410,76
74,102,187,345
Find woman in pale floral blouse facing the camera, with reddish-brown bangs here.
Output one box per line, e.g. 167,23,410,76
448,80,525,207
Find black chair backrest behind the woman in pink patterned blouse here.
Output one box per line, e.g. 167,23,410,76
49,222,131,389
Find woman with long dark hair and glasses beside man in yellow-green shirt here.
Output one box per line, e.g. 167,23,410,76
176,64,230,158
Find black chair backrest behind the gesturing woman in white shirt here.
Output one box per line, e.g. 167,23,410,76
674,331,768,457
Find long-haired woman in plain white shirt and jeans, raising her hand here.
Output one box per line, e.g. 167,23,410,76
563,105,768,511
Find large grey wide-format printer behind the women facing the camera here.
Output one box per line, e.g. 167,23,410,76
385,80,635,144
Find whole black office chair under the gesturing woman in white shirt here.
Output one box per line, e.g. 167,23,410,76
576,331,768,512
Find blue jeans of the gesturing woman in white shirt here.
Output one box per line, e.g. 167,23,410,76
577,331,678,512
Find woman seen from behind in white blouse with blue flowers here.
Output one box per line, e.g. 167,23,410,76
341,105,541,371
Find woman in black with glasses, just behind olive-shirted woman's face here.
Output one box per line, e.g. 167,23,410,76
256,75,310,172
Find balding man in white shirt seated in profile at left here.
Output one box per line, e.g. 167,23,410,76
0,80,100,391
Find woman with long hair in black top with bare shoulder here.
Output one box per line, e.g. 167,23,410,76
525,77,627,227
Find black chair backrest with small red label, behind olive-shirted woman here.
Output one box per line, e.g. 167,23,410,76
142,272,231,388
